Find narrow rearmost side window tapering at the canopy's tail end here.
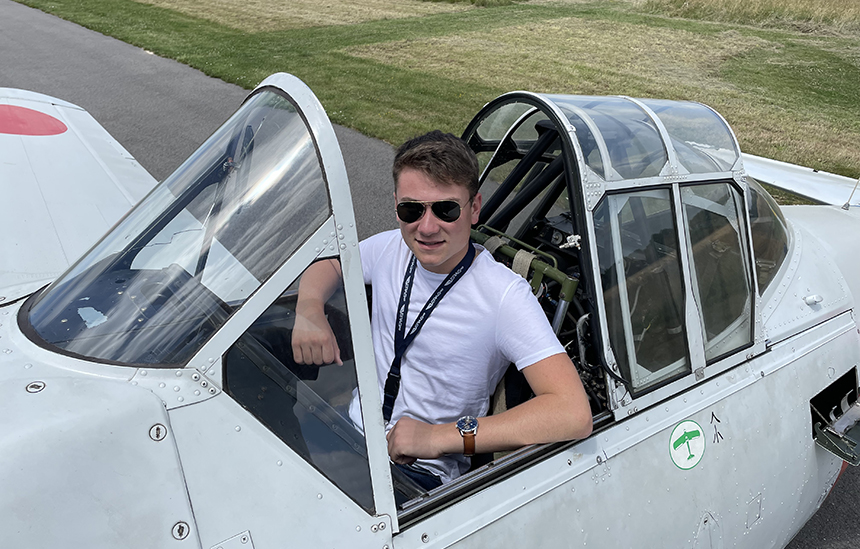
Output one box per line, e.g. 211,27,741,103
747,177,788,295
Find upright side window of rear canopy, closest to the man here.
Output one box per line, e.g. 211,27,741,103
594,189,690,392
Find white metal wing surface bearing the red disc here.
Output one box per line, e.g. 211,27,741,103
0,88,156,303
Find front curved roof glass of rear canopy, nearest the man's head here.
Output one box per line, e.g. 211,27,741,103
547,95,669,179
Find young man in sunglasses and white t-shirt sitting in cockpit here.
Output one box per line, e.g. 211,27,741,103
293,131,592,488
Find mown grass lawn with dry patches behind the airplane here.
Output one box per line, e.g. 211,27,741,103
15,0,860,184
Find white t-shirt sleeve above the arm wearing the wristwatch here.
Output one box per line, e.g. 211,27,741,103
496,279,564,370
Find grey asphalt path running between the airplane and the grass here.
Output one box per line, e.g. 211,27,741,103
0,0,860,549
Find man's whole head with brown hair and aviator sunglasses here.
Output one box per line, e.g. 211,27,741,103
392,130,481,273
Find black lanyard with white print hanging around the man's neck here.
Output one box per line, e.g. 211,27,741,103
382,240,475,423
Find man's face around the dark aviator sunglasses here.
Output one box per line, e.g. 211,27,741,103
394,168,481,274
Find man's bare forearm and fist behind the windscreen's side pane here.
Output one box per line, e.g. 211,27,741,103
292,259,343,365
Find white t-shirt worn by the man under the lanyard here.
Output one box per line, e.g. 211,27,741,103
350,229,564,482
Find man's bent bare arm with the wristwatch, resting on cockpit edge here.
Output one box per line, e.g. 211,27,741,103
388,353,592,463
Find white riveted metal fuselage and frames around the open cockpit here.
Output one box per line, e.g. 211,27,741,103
0,74,860,549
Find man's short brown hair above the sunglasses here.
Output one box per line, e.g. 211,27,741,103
391,130,478,198
